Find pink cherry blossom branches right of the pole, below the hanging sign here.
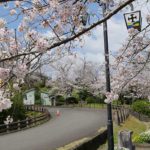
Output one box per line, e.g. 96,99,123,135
112,24,150,100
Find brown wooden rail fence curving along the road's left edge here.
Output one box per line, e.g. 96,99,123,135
0,106,51,135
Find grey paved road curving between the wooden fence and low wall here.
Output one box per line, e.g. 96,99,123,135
0,108,106,150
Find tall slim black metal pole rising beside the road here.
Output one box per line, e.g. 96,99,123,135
102,4,114,150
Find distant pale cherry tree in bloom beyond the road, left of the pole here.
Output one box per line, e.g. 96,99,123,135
50,54,105,93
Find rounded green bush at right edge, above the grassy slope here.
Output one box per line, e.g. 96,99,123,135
132,100,150,117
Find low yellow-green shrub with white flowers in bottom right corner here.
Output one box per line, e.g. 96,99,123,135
133,130,150,143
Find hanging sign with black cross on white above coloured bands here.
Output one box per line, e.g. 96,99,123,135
124,11,142,31
